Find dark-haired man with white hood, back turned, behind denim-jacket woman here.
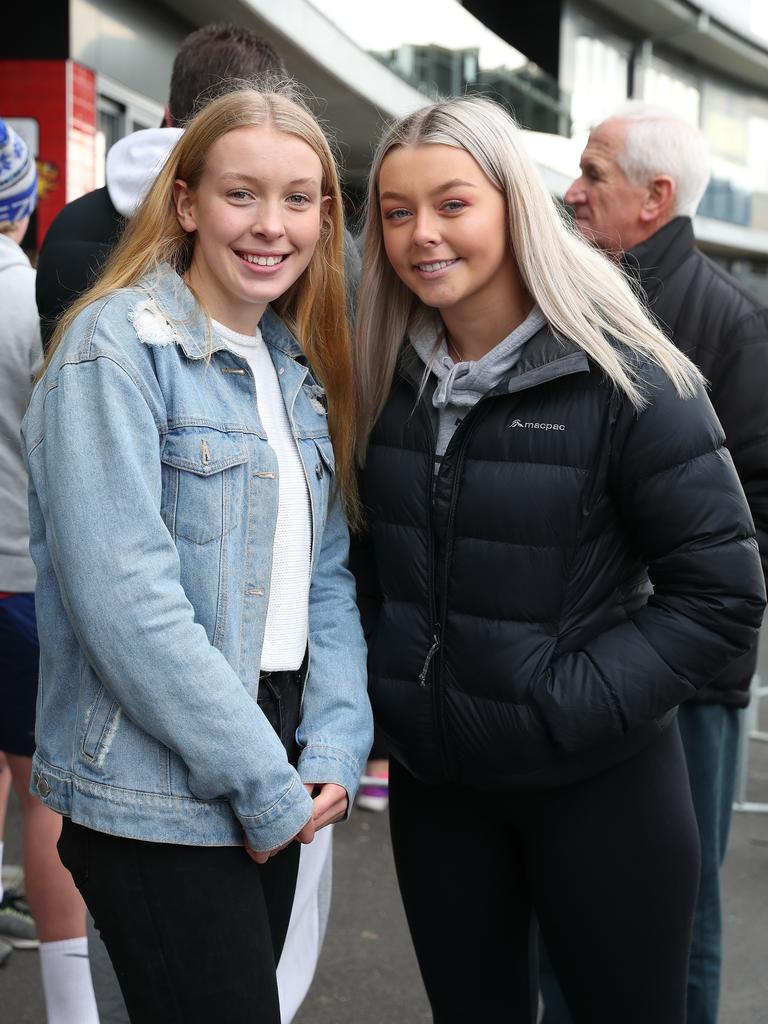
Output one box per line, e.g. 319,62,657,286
36,24,288,349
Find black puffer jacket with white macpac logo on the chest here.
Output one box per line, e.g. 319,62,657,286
357,329,765,787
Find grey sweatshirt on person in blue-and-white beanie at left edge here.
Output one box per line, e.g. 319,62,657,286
0,234,42,593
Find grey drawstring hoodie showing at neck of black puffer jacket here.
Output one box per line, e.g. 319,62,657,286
409,306,547,456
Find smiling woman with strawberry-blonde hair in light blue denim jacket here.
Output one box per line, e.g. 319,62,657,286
23,88,371,1024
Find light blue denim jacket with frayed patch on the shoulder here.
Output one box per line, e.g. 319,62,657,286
23,270,372,850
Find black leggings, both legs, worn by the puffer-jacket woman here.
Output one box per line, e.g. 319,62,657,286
389,724,698,1024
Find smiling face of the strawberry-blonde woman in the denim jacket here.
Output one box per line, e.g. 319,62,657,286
174,124,330,334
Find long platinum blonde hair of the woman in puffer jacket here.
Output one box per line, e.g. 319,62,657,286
355,96,702,461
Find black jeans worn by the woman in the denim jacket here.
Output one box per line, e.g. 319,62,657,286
58,672,301,1024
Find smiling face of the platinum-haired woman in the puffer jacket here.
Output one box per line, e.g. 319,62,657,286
379,143,519,327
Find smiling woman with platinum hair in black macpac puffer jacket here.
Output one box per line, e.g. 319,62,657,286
355,97,765,1024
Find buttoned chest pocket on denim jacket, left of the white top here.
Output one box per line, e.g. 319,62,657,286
160,427,248,545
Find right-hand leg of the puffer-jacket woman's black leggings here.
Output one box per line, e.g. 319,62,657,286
525,726,698,1024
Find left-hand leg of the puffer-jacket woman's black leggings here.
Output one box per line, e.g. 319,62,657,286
389,761,537,1024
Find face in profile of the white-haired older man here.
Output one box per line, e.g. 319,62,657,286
565,120,649,253
